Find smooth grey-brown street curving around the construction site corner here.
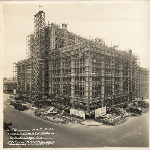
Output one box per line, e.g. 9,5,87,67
3,95,149,148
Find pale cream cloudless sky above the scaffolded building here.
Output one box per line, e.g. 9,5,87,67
2,1,150,77
